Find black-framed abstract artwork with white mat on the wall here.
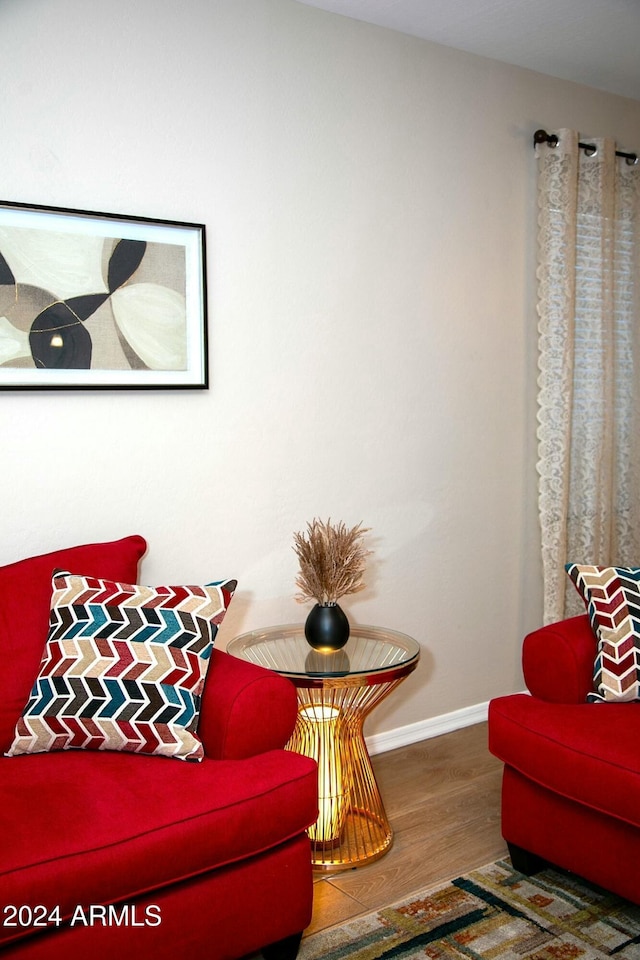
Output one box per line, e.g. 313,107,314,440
0,202,208,389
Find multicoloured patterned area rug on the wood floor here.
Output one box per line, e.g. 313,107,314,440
298,860,640,960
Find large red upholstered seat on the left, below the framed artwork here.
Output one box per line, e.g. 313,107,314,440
0,537,317,960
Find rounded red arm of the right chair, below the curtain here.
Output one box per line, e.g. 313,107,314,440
522,614,597,703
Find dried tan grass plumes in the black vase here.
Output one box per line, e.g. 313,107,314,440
293,519,371,606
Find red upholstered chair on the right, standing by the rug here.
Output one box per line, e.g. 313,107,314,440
489,614,640,903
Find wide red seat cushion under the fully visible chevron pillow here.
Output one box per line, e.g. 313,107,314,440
0,750,317,939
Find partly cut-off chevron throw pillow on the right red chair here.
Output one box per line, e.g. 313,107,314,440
565,563,640,702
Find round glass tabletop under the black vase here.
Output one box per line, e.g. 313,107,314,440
227,623,420,678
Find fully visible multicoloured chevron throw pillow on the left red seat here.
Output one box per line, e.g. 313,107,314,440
7,571,236,761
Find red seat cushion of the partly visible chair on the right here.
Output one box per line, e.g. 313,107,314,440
489,694,640,826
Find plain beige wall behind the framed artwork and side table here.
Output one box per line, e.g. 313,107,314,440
0,0,640,733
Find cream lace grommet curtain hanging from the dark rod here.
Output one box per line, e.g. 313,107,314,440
536,130,640,623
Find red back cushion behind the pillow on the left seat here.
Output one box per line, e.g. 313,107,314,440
0,536,147,754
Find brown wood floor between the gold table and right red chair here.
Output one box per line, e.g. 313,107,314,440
306,723,506,936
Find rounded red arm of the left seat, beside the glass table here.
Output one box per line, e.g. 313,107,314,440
198,648,298,760
